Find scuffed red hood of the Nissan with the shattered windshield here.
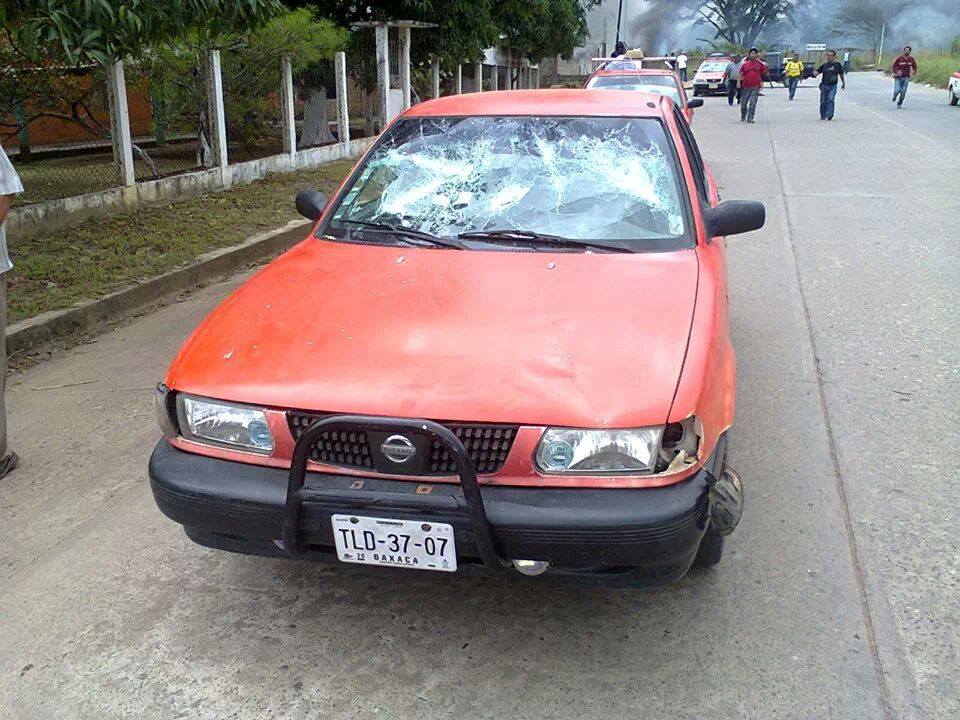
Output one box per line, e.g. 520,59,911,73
167,239,697,427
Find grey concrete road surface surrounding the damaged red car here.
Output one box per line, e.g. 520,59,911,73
0,75,960,720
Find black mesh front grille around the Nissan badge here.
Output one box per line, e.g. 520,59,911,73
287,412,517,475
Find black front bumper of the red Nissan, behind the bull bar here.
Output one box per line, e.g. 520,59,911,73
149,438,726,585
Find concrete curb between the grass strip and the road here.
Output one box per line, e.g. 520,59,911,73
7,220,310,355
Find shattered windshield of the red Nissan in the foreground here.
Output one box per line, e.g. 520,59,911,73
320,117,692,251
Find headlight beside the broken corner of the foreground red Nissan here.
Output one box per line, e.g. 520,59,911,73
537,427,663,474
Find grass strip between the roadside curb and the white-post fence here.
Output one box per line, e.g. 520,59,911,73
8,160,354,322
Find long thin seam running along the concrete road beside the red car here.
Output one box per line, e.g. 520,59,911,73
767,131,894,720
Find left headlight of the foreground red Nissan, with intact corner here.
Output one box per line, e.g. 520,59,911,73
177,394,273,453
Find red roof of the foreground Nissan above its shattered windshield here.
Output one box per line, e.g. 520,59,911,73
403,89,670,117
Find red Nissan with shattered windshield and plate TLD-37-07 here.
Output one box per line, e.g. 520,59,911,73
149,90,764,584
